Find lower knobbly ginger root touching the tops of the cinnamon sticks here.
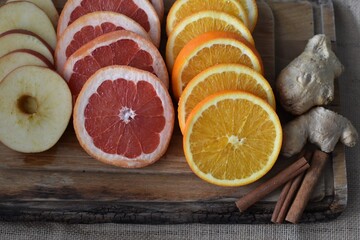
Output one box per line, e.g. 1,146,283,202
281,107,358,157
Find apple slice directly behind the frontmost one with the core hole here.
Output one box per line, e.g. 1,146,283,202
0,49,54,82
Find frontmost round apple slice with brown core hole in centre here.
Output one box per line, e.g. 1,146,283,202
0,66,72,153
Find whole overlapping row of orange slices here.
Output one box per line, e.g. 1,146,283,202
166,0,282,186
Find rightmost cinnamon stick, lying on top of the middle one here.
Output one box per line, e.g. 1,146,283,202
285,150,329,223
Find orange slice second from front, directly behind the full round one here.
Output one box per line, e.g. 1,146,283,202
178,64,276,132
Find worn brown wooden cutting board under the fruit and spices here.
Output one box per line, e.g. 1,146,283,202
0,0,347,224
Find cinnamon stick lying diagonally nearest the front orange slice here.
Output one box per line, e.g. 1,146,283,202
236,157,310,212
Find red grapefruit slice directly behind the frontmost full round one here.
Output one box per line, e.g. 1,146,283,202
63,30,169,98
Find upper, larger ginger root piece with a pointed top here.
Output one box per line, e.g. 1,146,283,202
276,34,344,115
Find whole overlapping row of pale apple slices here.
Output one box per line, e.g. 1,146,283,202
0,0,72,153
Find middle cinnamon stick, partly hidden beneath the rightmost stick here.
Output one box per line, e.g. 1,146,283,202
271,151,312,223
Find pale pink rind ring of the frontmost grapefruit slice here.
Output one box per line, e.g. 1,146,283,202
74,66,175,168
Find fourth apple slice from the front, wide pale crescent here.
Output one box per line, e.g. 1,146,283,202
0,1,56,49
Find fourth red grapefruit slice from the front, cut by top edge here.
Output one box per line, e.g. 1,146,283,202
57,0,161,46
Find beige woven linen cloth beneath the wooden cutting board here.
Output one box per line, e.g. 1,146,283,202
0,0,360,240
